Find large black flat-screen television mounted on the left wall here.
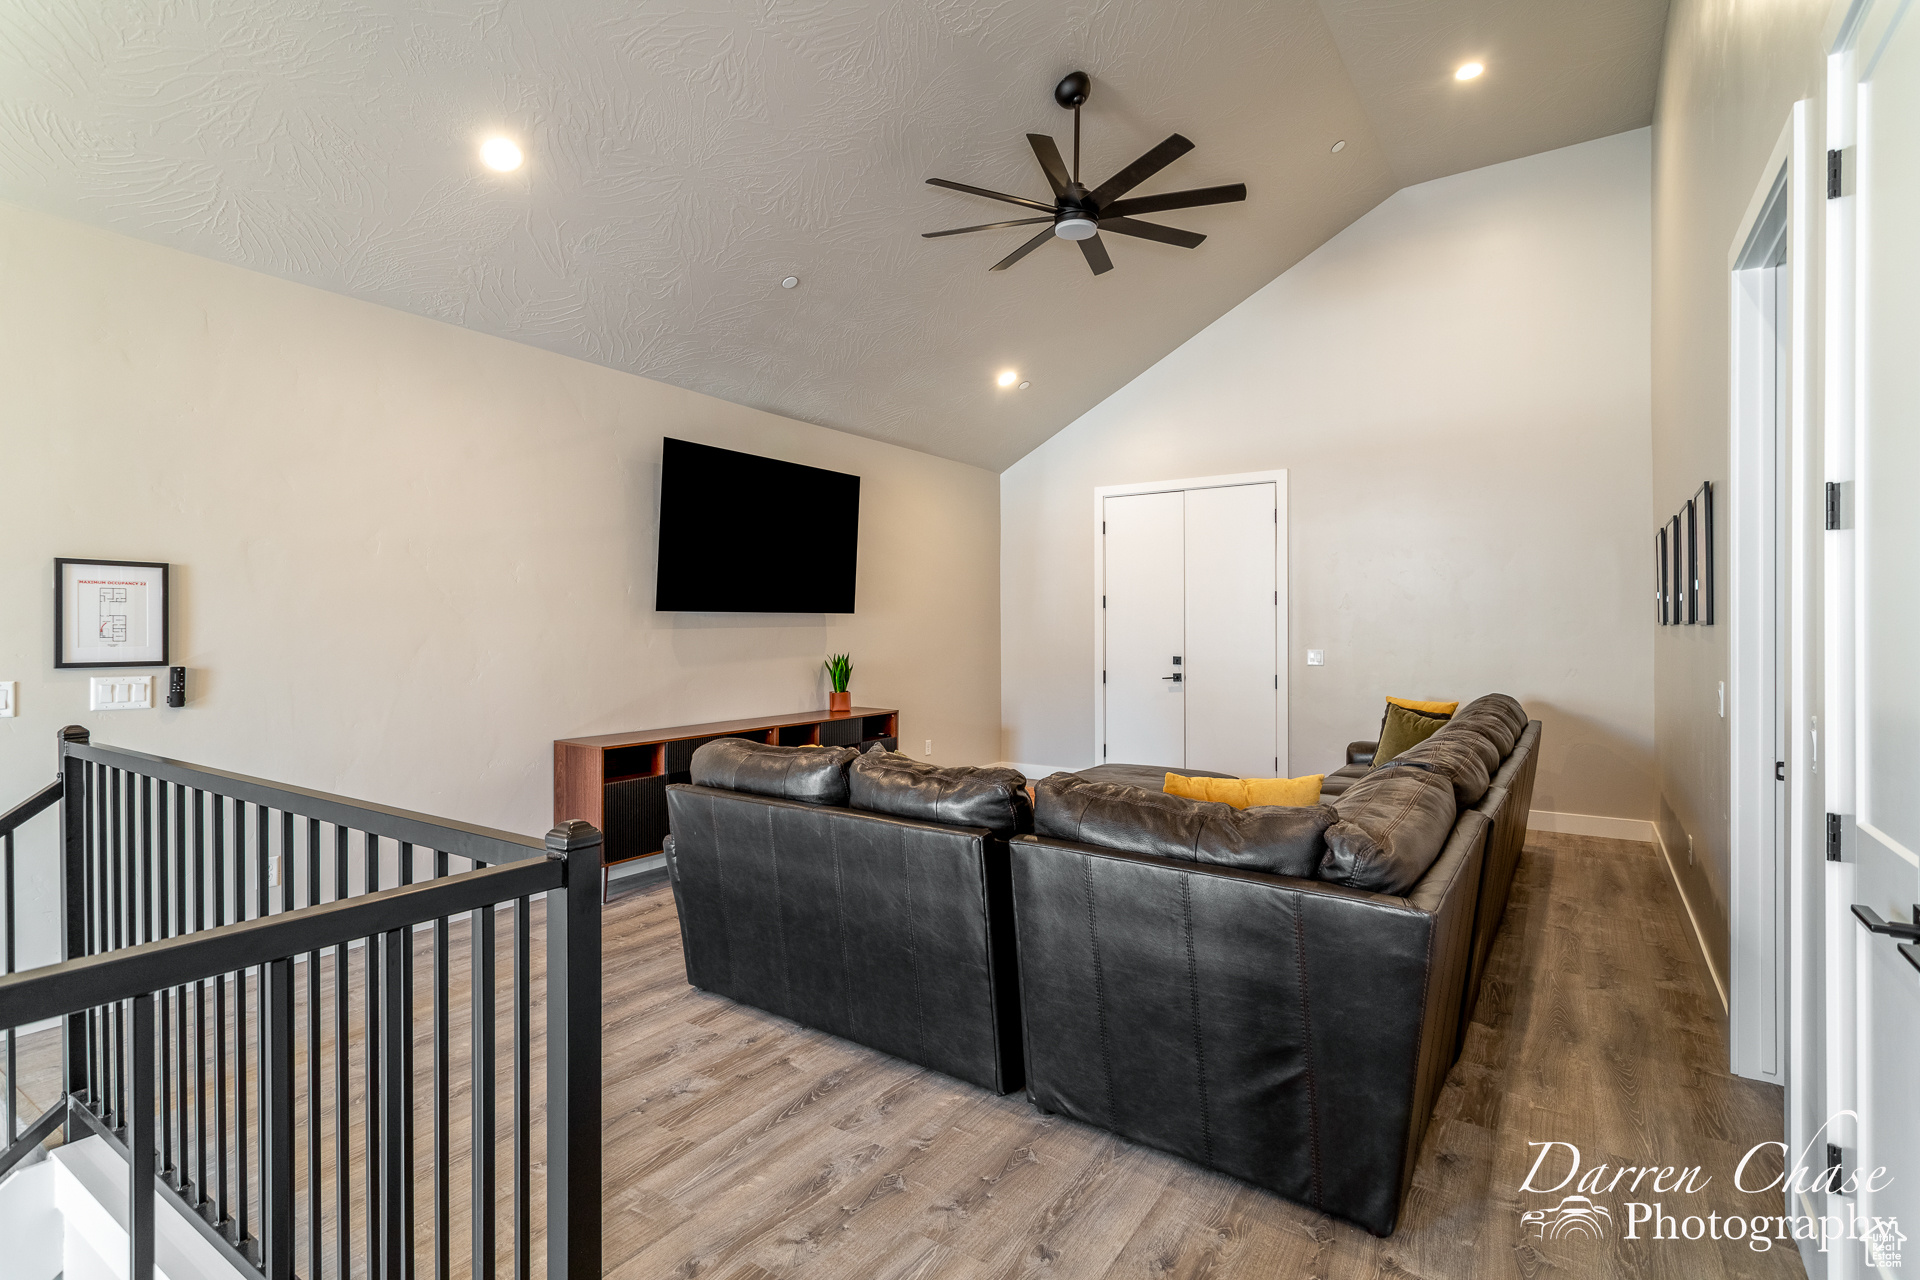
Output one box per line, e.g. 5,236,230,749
653,439,860,614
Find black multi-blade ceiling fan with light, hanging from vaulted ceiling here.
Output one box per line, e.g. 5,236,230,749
922,71,1246,276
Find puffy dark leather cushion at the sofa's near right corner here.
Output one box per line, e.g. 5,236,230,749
1319,766,1455,894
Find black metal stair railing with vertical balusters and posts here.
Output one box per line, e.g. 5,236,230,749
0,729,601,1280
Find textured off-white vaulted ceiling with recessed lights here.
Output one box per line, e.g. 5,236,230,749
0,0,1667,468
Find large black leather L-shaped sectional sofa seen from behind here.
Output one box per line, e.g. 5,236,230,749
666,695,1540,1236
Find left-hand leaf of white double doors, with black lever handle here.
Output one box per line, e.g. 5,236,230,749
1100,491,1187,766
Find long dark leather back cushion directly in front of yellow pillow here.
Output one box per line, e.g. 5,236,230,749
1033,773,1334,877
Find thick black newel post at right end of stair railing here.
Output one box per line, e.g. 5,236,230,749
547,821,601,1280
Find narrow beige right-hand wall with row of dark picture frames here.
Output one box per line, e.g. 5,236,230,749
1645,0,1830,975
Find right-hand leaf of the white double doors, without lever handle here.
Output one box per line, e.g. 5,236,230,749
1185,484,1284,777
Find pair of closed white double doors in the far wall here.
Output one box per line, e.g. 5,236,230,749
1094,472,1286,777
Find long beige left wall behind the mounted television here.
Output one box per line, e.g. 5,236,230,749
0,197,998,948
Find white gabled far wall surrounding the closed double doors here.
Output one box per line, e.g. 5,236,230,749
1000,129,1655,821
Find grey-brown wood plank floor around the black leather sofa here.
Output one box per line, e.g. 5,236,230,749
0,835,1801,1280
